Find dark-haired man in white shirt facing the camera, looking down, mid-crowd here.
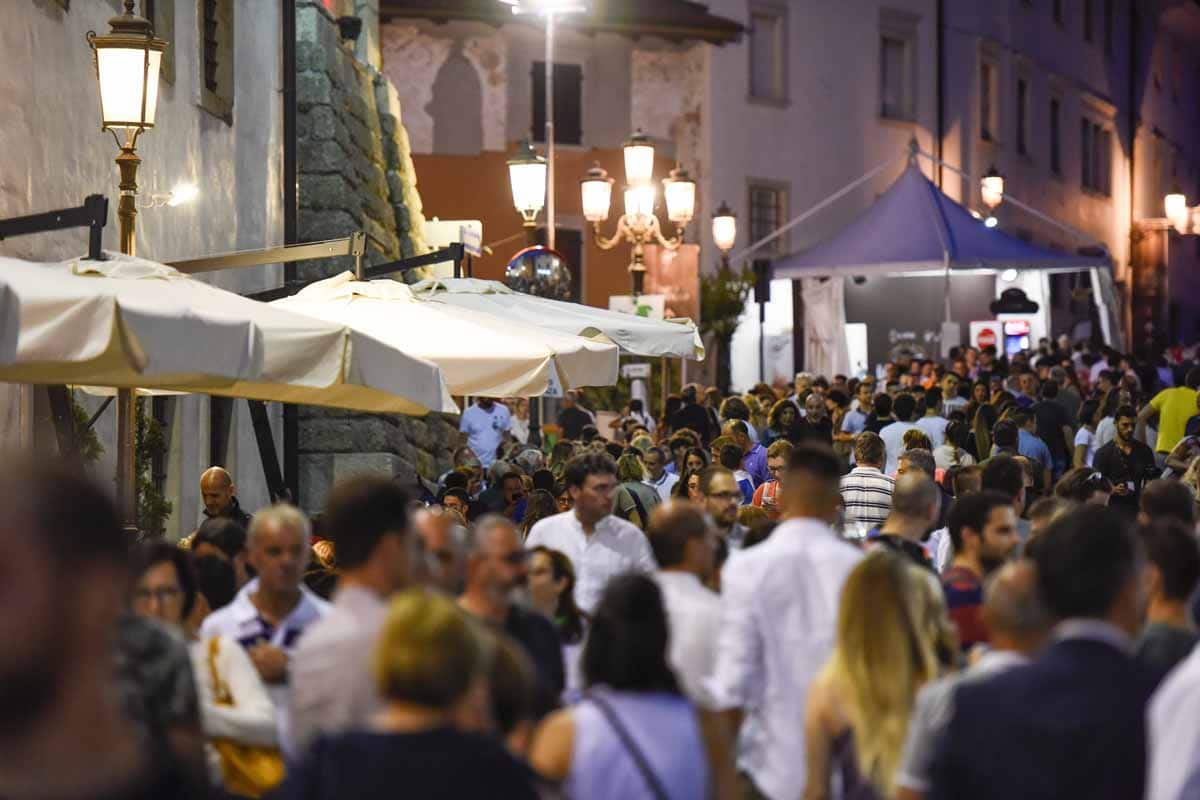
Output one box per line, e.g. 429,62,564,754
526,453,658,613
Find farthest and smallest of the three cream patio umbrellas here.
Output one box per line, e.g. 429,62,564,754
413,278,704,361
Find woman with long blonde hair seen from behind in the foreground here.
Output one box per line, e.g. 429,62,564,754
804,549,958,800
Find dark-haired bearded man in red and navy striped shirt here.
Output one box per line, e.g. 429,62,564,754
942,492,1020,650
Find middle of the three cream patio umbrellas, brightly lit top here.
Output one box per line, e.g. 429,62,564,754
271,272,619,397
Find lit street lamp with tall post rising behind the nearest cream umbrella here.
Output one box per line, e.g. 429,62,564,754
88,0,167,529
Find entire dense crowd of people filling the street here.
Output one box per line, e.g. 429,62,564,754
7,341,1200,800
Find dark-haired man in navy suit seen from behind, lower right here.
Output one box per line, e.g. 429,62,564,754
929,506,1153,800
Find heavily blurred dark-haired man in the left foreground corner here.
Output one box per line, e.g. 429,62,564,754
0,463,206,800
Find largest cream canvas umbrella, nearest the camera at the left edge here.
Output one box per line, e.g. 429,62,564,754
0,254,457,414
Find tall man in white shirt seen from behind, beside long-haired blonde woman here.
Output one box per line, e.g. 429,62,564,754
708,445,862,800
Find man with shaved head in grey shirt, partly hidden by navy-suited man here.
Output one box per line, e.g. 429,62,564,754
896,559,1052,800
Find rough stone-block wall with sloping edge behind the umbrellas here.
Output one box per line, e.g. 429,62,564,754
296,0,457,510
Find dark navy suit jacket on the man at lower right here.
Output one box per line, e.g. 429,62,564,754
926,639,1153,800
